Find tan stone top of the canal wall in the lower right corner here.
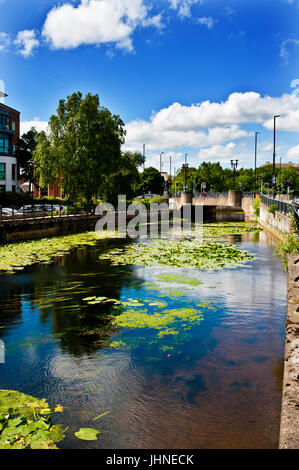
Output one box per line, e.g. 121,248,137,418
279,254,299,449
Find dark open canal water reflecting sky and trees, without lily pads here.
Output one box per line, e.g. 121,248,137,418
0,233,287,449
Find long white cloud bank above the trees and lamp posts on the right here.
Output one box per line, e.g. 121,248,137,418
126,92,299,154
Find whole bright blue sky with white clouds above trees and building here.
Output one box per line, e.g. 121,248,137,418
0,0,299,170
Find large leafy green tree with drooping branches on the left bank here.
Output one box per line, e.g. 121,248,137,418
34,92,125,201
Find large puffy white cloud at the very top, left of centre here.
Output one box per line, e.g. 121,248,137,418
42,0,162,51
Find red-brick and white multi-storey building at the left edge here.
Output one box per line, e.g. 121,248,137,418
0,103,20,192
